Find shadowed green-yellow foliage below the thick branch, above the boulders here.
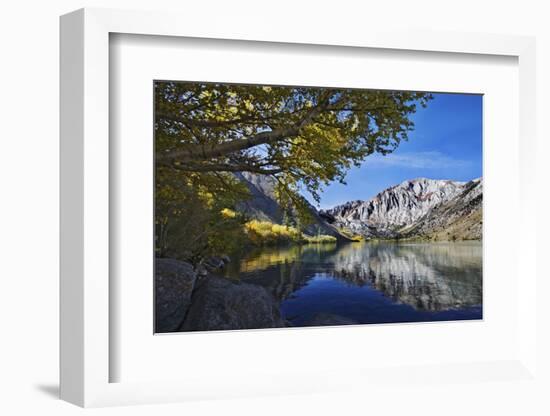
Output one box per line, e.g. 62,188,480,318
155,167,249,261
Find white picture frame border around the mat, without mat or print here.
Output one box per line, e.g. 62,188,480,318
60,9,540,407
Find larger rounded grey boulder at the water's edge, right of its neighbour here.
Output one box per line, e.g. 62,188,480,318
181,275,285,331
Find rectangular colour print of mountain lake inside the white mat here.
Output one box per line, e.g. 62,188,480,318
153,80,483,333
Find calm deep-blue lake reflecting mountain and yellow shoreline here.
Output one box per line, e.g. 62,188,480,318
225,241,482,326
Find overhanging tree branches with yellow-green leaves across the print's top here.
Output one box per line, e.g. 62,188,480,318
155,81,431,208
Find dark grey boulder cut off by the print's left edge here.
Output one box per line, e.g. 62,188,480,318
155,259,197,332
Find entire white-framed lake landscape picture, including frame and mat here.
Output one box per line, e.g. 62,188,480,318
61,9,537,406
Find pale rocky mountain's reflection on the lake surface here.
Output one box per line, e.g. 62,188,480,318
333,243,481,310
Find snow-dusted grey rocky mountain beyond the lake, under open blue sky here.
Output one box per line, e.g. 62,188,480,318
320,178,483,240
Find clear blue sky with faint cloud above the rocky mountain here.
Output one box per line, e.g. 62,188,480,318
312,94,482,208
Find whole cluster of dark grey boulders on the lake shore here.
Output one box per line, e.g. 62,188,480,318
155,258,285,332
